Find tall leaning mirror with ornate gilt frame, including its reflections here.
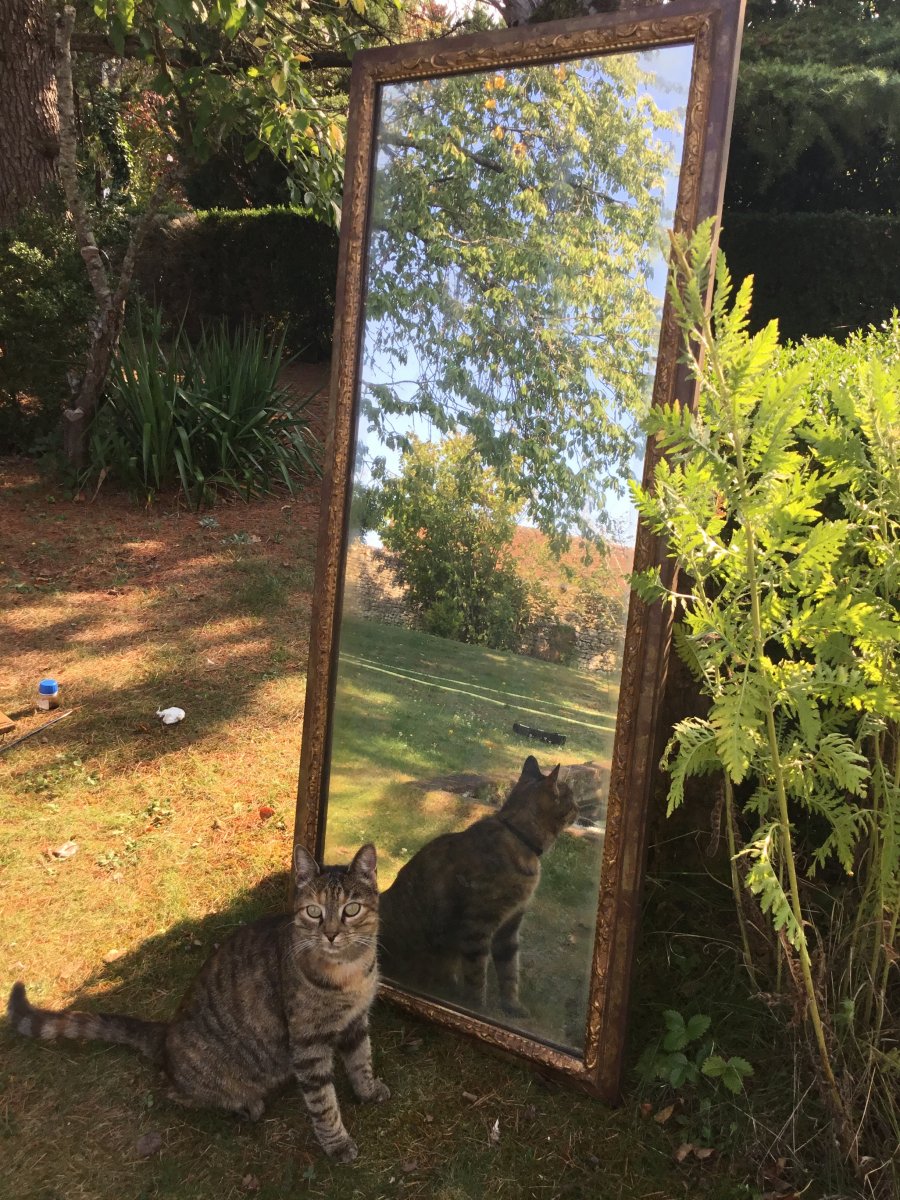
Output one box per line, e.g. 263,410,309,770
296,0,743,1098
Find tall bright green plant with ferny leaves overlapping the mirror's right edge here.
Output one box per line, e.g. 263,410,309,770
634,227,900,1195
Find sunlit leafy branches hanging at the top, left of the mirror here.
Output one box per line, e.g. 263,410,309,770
74,0,420,220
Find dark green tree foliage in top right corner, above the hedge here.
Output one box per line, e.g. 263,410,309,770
726,0,900,212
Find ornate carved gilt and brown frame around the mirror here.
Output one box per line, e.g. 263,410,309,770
294,0,744,1102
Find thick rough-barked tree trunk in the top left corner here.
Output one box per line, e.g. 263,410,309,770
0,0,59,226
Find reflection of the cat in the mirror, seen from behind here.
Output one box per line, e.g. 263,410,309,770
379,755,576,1016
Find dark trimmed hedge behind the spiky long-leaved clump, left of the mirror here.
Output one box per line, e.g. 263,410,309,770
137,208,337,360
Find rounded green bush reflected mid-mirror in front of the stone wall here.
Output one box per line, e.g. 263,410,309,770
370,436,528,649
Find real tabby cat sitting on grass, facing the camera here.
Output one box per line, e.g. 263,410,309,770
7,846,390,1163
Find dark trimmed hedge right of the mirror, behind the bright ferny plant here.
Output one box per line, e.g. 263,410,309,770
721,211,900,341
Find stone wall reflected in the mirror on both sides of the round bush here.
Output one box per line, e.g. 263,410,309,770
344,541,624,673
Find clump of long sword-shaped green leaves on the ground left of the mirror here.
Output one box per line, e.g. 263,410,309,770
88,311,319,508
